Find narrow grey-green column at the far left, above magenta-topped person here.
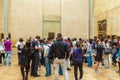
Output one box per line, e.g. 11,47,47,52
4,0,8,38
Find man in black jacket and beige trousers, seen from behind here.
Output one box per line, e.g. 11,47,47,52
50,33,70,80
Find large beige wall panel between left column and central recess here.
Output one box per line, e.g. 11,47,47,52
9,0,42,41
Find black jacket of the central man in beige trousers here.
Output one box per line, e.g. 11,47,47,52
50,40,71,59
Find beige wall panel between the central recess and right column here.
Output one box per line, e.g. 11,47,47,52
61,0,89,38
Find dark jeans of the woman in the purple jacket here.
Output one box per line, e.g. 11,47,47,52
74,60,83,80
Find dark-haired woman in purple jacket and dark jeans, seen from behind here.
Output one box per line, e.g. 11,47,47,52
73,42,84,80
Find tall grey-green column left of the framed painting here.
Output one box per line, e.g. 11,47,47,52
89,0,94,39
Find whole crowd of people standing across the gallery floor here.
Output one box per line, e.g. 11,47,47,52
0,33,120,80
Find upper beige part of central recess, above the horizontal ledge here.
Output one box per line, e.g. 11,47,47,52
42,0,61,20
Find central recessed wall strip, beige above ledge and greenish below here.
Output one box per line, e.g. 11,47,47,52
42,0,61,38
